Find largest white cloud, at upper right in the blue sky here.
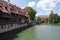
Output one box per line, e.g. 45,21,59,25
37,0,60,11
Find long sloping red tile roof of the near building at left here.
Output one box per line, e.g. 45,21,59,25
0,0,28,16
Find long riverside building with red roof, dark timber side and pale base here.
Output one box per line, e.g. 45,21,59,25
0,0,28,33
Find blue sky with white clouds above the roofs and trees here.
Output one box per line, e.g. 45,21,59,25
5,0,60,15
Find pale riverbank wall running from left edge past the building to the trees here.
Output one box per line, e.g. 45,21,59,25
0,23,35,34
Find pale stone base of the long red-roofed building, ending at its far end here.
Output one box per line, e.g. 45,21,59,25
0,23,28,33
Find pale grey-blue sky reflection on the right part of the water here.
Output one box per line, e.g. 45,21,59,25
35,25,60,40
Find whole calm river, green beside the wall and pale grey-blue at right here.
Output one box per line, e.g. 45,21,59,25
0,24,60,40
